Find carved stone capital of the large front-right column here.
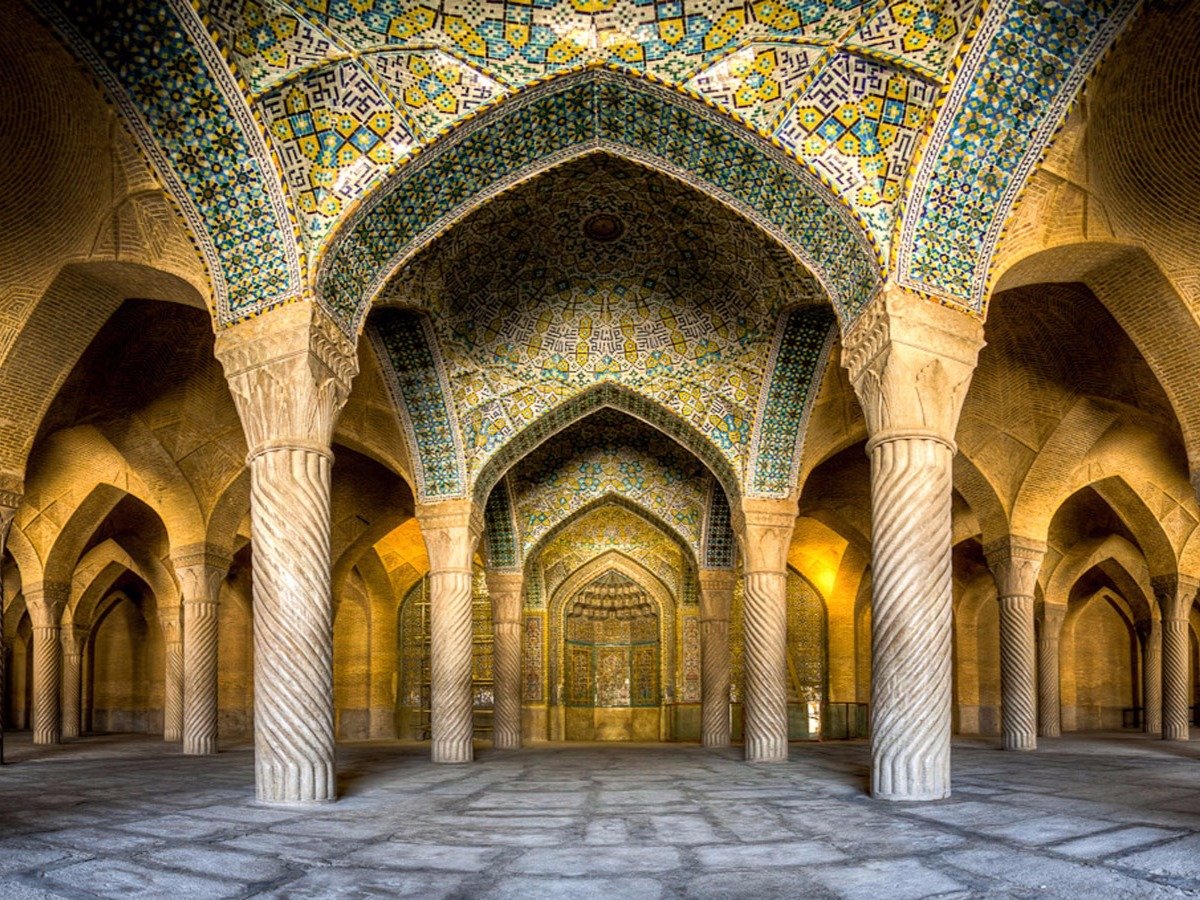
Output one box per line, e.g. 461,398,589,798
841,284,984,450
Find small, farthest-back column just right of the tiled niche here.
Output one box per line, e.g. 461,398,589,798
700,569,734,746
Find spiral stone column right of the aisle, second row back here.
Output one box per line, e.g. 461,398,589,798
742,499,797,762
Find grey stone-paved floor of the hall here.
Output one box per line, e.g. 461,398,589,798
0,736,1200,900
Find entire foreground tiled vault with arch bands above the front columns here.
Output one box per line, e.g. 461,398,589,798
34,0,1136,331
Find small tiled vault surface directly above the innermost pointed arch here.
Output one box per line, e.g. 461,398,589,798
508,409,709,564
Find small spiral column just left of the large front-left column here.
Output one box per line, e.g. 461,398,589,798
167,544,230,756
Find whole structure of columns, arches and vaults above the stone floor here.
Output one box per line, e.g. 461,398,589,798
0,0,1200,830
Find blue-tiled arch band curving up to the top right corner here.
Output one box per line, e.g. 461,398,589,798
896,0,1138,311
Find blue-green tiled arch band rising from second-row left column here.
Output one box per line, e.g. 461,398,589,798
367,310,467,499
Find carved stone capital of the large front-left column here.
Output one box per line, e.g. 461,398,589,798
216,301,359,458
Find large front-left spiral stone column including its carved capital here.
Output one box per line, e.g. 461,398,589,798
214,301,358,803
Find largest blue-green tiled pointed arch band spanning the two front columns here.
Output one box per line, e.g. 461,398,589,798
317,70,880,324
